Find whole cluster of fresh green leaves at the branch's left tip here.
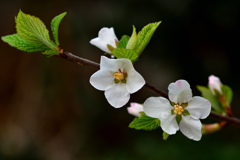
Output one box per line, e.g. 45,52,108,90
2,10,66,56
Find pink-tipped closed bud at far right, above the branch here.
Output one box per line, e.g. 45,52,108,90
208,75,222,95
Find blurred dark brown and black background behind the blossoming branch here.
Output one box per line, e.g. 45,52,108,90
0,0,240,160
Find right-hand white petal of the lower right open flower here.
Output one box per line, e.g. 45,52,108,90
186,96,211,119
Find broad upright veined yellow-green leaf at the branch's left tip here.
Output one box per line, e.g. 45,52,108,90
16,11,58,51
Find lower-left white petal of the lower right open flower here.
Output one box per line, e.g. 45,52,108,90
159,111,179,134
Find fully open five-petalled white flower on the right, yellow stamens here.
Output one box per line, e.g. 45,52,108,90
143,80,211,141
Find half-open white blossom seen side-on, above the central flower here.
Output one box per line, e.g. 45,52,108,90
90,27,118,53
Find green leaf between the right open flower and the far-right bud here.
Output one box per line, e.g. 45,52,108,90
197,86,225,113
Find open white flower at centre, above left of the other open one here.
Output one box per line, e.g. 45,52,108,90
90,56,145,108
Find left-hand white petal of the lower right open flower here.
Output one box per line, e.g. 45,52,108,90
143,97,173,118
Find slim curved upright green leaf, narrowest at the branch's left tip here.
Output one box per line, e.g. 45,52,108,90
51,12,67,45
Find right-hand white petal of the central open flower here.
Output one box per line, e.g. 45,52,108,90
126,69,145,93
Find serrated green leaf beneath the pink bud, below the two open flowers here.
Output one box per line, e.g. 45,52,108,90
129,113,160,131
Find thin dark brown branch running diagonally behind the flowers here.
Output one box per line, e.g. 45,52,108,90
57,52,240,126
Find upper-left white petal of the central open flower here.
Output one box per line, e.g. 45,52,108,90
100,56,119,71
